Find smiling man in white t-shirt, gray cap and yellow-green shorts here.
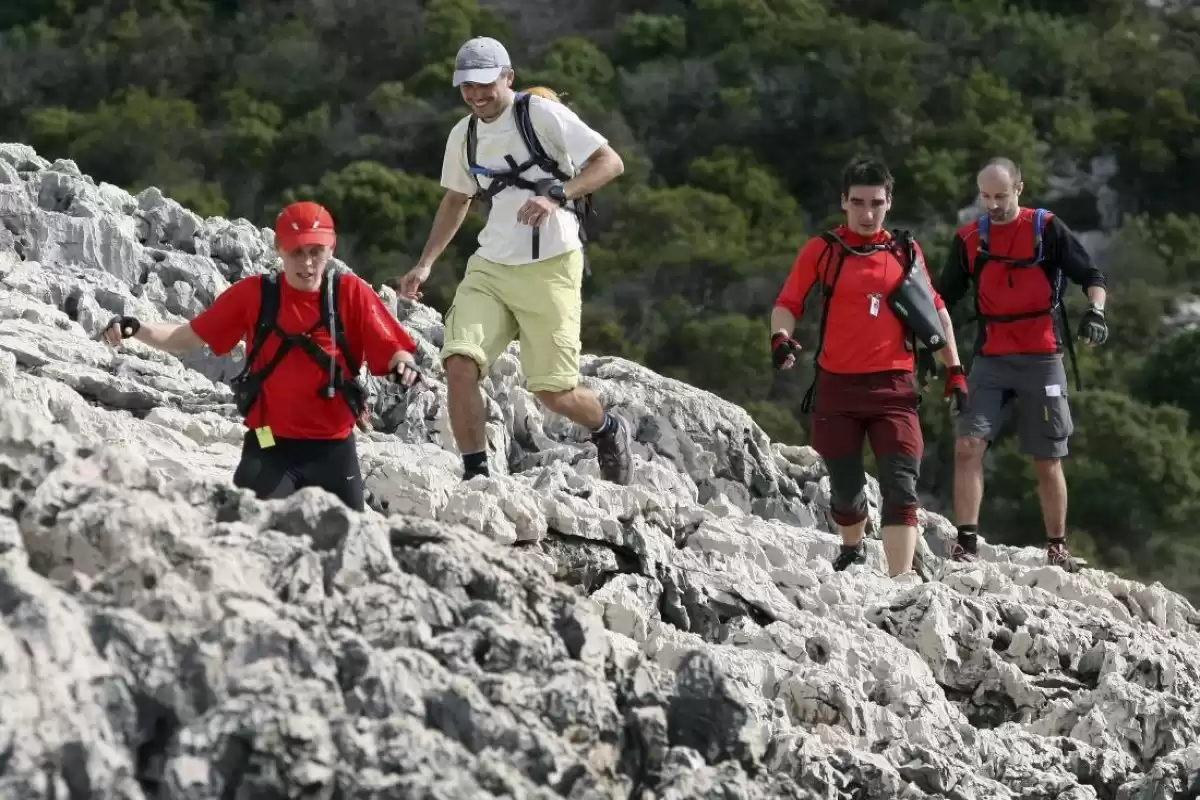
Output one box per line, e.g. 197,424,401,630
400,36,634,485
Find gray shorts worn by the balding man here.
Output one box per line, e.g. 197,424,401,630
955,355,1075,458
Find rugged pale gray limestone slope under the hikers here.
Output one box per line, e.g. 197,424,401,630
0,145,1200,800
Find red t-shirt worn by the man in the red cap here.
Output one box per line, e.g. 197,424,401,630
191,273,416,439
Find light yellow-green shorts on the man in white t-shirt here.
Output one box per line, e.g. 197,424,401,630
442,249,583,392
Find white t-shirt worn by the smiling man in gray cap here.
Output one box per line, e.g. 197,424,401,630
442,95,607,264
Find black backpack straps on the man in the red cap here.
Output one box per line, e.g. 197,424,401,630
229,266,366,419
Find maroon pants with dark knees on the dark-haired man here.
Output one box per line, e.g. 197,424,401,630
812,371,925,525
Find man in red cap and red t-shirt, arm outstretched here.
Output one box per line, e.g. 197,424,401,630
104,201,419,511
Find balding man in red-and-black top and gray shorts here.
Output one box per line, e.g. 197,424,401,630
937,158,1109,572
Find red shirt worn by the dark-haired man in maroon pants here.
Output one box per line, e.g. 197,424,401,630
775,225,946,374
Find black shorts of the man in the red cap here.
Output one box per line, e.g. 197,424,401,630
233,431,366,511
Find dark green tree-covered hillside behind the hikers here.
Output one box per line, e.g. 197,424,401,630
0,0,1200,593
